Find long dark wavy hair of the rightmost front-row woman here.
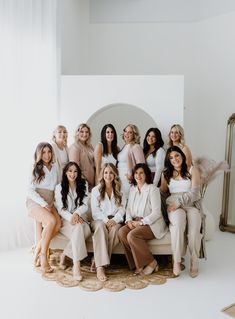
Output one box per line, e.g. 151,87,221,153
163,145,191,184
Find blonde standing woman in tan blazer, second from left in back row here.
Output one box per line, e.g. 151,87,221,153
69,123,95,191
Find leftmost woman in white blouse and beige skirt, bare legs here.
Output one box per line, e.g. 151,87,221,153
26,142,61,272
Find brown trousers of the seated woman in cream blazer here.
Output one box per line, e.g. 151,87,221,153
118,225,155,269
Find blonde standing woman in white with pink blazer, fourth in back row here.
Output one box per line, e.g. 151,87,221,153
117,124,145,198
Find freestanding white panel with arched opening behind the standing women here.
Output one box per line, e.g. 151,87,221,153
59,75,184,145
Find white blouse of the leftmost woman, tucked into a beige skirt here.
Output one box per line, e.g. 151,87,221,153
28,163,58,207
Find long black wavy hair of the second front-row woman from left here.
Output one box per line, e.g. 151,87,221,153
61,162,87,209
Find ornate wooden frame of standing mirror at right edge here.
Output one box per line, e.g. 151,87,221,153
219,113,235,233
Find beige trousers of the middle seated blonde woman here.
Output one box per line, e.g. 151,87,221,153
91,220,121,267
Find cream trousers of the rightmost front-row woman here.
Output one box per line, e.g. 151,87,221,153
168,207,202,262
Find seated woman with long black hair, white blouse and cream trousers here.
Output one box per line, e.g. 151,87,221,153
55,162,91,281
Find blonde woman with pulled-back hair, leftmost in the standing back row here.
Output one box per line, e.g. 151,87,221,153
51,125,69,182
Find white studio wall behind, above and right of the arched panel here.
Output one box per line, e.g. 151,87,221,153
62,0,235,228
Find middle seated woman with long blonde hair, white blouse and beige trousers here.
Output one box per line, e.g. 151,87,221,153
91,163,125,281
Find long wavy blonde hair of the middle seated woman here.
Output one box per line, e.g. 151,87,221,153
98,163,122,206
